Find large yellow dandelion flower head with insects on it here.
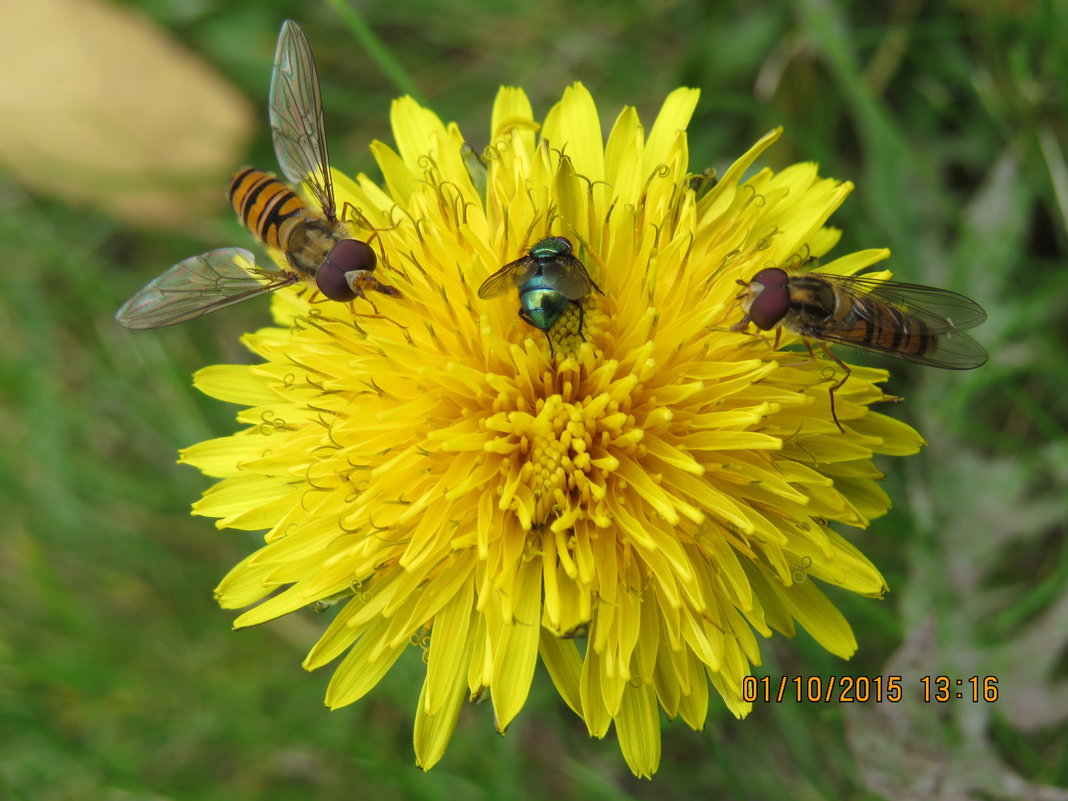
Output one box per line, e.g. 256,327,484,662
183,84,922,775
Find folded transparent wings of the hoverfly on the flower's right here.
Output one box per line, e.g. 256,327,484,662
818,273,988,370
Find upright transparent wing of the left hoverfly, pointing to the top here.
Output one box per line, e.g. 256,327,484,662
269,19,336,221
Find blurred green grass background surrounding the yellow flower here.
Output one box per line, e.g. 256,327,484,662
0,0,1068,801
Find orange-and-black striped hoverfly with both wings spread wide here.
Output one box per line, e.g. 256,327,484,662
115,19,399,329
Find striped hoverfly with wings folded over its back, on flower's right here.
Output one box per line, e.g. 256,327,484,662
732,258,987,429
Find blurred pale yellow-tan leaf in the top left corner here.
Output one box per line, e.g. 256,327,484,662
0,0,254,227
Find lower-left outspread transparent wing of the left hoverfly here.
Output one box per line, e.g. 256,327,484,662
115,248,297,330
